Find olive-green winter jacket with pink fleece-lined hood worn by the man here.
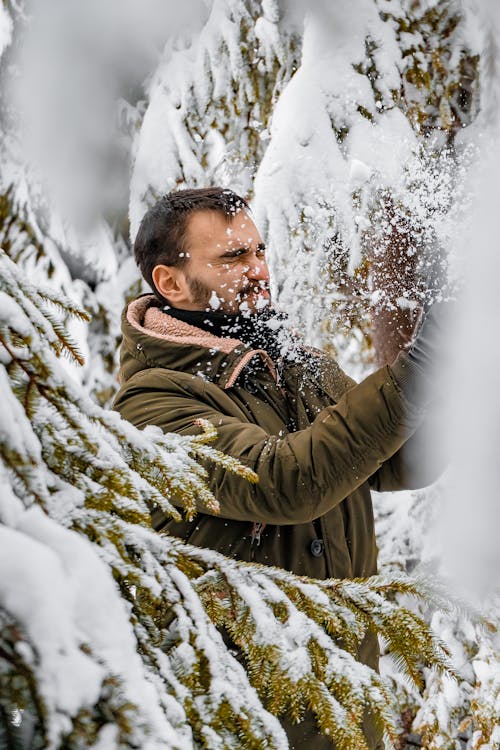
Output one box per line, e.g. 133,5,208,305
114,295,433,750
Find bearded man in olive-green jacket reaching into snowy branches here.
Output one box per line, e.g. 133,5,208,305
115,188,442,750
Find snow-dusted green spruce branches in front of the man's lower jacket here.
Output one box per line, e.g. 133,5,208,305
0,247,468,750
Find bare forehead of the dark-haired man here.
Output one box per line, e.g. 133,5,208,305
186,210,262,252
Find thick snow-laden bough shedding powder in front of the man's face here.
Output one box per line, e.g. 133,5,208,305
255,2,477,364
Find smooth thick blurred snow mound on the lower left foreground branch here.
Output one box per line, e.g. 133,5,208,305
0,507,190,748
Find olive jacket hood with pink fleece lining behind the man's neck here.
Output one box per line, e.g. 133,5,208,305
119,294,275,388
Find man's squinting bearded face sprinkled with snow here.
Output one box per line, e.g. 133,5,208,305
179,210,271,313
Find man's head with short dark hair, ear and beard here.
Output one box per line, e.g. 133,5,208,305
134,187,270,313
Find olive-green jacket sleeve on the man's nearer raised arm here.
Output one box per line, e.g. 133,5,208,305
114,360,421,524
